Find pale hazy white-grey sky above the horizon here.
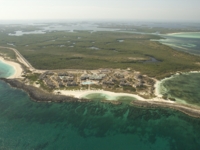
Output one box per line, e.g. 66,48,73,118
0,0,200,22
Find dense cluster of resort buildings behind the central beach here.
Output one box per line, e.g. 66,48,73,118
36,69,154,96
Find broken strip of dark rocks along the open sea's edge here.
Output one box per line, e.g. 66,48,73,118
0,78,200,118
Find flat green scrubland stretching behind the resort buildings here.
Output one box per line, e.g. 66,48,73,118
0,28,200,78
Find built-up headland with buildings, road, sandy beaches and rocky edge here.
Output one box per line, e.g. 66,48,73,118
0,47,200,118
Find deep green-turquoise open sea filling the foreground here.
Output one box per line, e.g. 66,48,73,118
0,57,200,150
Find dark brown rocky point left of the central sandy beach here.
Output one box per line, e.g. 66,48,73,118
0,78,89,102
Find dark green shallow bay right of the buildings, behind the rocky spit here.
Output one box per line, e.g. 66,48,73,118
160,73,200,106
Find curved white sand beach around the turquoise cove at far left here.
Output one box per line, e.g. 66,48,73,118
0,57,23,79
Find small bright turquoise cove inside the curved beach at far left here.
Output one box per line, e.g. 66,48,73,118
0,61,15,77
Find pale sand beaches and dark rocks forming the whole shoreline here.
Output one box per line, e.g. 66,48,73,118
0,52,200,118
